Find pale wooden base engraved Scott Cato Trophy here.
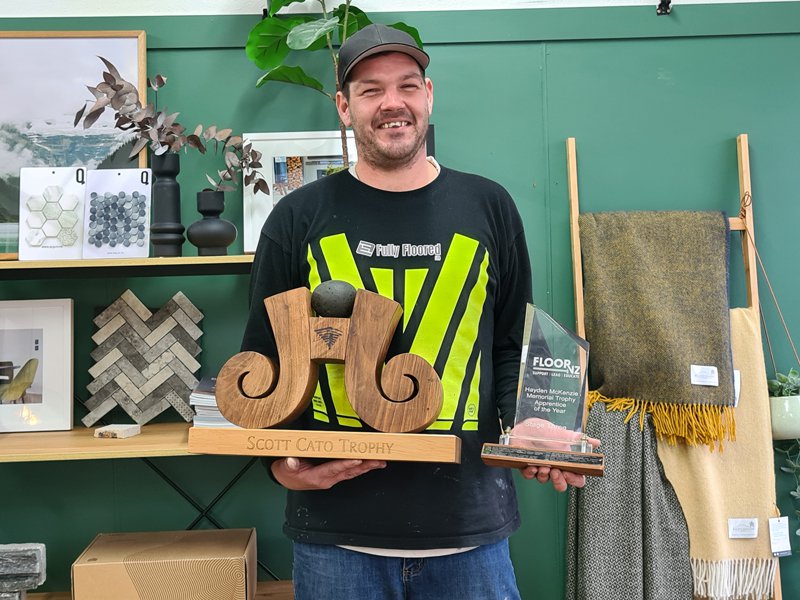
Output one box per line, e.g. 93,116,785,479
189,427,461,464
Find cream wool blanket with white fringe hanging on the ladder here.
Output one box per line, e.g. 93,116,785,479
658,308,778,600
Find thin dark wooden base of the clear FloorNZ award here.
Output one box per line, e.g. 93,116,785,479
478,444,605,477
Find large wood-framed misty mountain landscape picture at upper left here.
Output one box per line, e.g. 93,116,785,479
0,31,147,260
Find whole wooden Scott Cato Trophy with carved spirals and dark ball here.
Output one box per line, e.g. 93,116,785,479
189,281,461,463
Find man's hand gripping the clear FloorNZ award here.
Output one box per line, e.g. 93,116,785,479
511,419,600,492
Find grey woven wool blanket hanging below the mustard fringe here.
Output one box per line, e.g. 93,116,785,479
565,403,692,600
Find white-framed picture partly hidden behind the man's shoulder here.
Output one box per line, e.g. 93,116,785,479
244,130,356,253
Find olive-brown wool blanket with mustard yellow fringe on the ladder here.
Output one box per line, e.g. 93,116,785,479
579,211,735,446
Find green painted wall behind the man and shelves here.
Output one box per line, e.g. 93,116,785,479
0,2,800,600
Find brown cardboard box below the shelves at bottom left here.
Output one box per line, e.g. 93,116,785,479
72,529,256,600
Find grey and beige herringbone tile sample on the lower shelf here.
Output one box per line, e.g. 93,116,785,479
82,290,203,427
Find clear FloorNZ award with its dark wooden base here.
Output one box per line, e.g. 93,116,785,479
481,304,604,475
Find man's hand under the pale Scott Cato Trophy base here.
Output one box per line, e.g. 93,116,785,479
271,457,386,491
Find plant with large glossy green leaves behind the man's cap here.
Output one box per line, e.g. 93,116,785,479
245,0,422,167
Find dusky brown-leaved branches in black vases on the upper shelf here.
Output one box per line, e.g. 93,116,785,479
74,57,269,256
